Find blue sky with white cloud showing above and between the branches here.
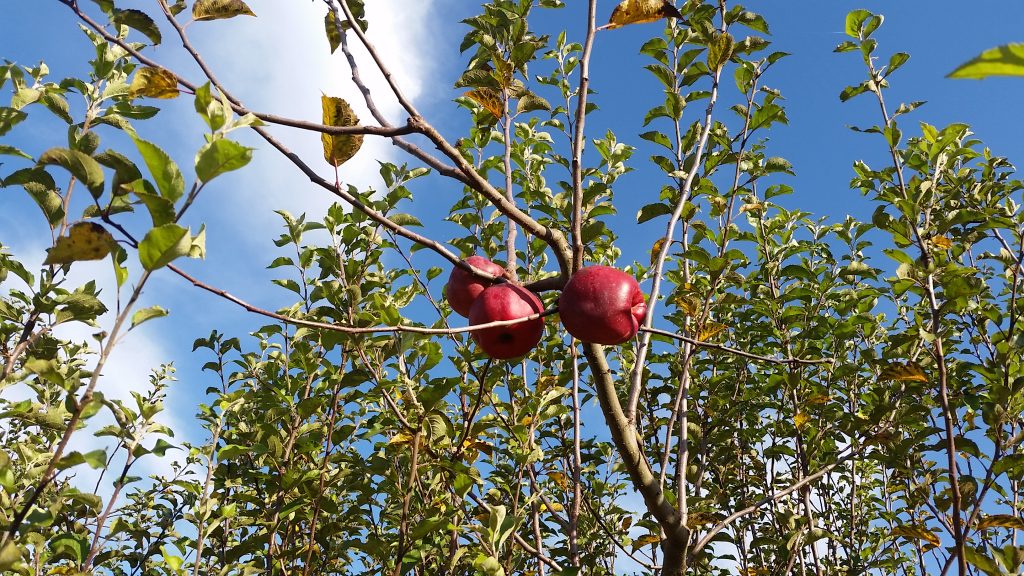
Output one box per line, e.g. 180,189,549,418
0,0,1024,565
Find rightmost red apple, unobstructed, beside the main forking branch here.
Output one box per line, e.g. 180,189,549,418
558,265,647,344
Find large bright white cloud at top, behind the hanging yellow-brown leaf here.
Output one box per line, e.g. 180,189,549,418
174,0,436,236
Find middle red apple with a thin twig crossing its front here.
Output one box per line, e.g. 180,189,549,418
469,283,544,360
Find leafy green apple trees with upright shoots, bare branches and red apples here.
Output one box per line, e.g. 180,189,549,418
0,0,1024,576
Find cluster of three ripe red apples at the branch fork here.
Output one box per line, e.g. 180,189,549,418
445,256,647,360
